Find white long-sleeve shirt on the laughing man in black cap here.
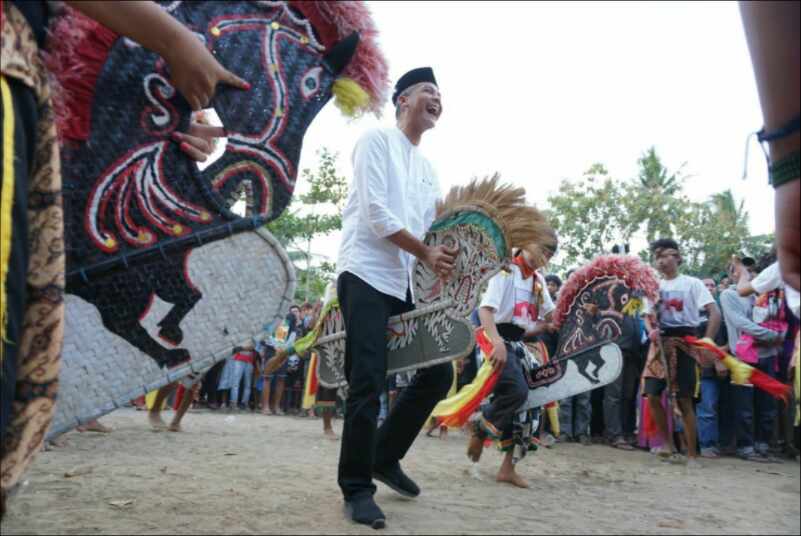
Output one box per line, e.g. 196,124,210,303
337,127,440,300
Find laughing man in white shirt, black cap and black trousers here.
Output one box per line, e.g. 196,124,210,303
337,67,457,528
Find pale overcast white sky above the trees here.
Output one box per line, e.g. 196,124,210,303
233,2,773,266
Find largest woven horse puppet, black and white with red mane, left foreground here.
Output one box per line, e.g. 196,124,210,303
45,1,388,431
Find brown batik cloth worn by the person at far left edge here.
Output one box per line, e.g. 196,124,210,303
0,2,64,500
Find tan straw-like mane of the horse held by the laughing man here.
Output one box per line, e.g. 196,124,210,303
437,173,554,255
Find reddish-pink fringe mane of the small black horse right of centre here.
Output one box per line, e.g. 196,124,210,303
554,255,659,327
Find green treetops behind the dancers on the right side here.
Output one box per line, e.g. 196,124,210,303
548,147,773,276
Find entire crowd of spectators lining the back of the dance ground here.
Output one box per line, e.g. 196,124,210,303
142,246,799,463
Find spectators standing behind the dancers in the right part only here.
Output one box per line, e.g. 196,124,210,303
544,249,799,463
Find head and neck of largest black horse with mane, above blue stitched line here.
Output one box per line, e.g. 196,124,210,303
50,1,387,277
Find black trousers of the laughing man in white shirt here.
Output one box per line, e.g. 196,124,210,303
337,272,453,501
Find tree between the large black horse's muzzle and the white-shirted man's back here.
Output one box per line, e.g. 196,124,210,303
266,147,348,302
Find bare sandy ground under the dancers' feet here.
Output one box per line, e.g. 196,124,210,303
2,410,801,535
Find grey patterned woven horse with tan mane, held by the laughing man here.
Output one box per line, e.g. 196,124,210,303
313,175,551,387
